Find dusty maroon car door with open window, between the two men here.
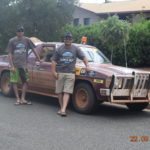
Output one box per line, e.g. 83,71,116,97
33,46,56,95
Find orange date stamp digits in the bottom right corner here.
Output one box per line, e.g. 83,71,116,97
129,135,150,142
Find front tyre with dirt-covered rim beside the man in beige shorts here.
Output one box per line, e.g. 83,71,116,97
72,83,97,114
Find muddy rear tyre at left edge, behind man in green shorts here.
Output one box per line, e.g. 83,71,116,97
0,72,14,97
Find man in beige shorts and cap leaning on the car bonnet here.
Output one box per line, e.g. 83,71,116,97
52,33,88,116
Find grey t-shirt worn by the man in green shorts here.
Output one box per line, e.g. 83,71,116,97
7,37,35,68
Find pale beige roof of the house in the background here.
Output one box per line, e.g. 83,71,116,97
80,0,150,14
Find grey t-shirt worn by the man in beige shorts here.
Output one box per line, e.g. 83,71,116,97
52,44,85,73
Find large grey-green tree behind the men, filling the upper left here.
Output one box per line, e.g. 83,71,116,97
0,0,76,53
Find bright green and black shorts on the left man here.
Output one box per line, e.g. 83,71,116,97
10,68,29,83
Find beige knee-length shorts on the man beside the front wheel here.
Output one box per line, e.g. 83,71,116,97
56,73,75,94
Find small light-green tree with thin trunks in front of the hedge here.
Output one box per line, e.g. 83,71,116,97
100,15,129,67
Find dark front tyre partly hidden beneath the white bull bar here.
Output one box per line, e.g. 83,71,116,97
126,102,149,111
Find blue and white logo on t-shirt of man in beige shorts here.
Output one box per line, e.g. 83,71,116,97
60,52,74,64
